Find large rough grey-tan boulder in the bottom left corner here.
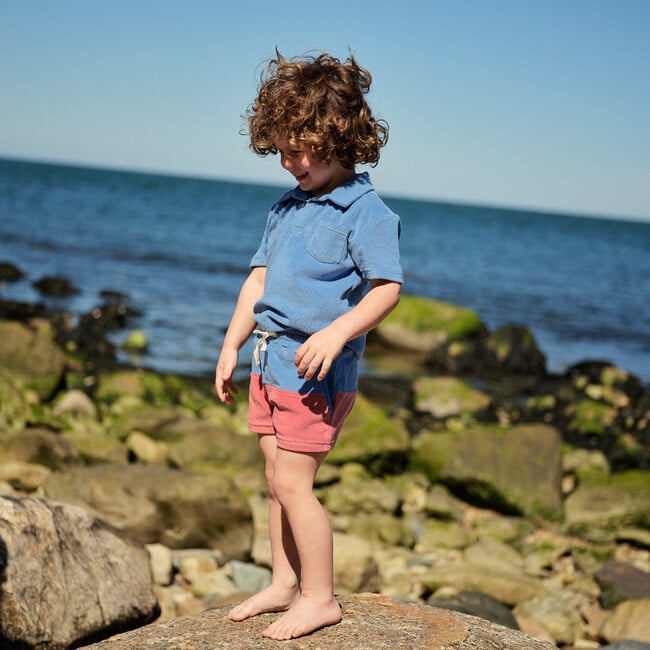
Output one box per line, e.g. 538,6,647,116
0,497,159,650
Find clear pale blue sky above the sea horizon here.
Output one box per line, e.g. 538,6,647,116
0,0,650,219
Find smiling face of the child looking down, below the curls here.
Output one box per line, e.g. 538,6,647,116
275,137,354,196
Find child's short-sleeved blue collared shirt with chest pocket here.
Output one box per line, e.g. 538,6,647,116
250,173,402,356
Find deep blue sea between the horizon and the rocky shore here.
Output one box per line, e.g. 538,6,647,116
0,160,650,383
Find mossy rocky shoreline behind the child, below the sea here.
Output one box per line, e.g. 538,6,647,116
0,264,650,650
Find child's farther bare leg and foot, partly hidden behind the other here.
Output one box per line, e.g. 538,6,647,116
228,435,300,621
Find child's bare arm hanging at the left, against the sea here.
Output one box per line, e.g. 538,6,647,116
214,266,266,404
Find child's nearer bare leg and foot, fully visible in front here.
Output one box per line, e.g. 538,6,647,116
262,449,341,640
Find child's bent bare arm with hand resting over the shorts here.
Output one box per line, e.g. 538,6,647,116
295,280,402,381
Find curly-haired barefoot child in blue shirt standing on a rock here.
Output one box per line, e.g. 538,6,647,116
215,49,402,640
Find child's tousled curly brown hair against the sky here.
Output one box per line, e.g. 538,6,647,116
244,50,388,169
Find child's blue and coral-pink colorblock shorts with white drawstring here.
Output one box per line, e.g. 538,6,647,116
248,330,358,452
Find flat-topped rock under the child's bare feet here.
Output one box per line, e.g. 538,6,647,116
81,594,555,650
